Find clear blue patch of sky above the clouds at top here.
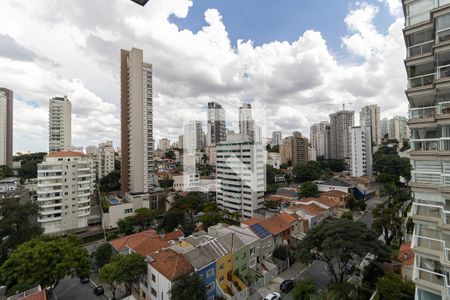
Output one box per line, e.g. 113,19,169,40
170,0,394,53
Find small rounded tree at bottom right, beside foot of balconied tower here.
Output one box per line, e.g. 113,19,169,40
376,272,415,300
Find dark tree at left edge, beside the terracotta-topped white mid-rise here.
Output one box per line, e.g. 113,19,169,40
0,198,43,265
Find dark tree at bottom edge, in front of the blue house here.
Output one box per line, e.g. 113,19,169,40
170,274,206,300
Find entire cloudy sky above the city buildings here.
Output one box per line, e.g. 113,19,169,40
0,0,408,151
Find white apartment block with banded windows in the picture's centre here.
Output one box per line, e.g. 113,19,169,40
216,134,266,218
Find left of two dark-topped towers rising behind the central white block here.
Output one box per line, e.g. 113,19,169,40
206,102,226,146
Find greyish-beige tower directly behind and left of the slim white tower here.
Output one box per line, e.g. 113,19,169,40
330,110,355,159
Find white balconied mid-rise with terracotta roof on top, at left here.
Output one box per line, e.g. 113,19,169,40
37,151,94,233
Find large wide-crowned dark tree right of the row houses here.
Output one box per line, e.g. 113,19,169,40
297,219,387,283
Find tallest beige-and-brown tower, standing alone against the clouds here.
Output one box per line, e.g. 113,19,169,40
120,48,155,194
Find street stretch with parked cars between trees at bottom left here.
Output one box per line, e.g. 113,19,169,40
52,277,106,300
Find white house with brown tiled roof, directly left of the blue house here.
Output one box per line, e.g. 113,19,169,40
140,249,194,300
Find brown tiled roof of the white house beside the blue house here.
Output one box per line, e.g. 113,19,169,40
150,249,193,281
